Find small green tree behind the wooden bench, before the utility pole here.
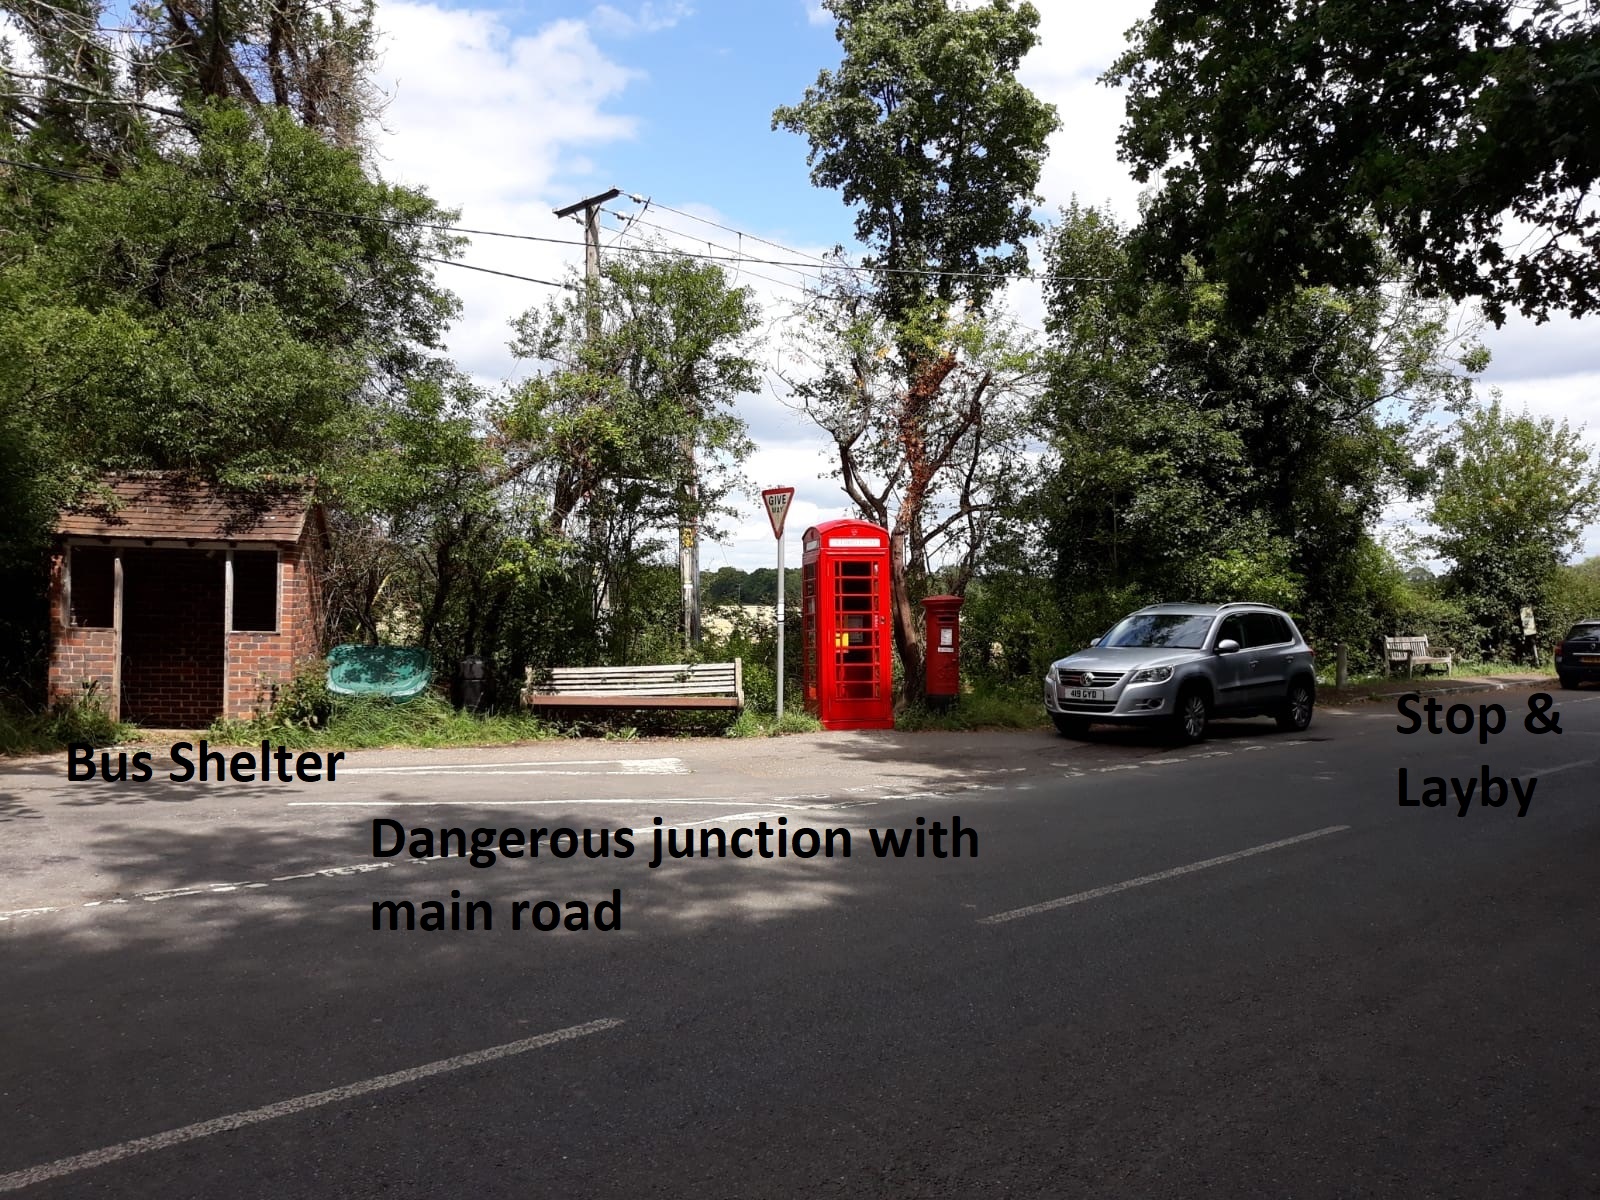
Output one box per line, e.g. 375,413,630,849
490,253,758,653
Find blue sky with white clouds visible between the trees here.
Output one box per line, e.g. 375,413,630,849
363,0,1600,574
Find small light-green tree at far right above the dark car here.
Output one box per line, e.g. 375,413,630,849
1426,397,1600,645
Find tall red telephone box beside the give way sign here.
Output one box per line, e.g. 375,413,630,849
800,520,894,730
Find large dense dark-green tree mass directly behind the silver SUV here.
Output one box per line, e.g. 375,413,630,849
1022,205,1486,649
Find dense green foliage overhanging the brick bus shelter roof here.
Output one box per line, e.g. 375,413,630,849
0,109,454,694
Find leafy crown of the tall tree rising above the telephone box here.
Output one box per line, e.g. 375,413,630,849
773,0,1056,324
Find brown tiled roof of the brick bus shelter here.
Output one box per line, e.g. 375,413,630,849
56,474,310,542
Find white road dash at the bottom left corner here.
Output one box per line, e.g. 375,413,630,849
0,1018,622,1192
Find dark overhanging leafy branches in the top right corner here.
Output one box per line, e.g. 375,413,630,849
1106,0,1600,325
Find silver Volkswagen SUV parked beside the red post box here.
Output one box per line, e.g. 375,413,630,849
1045,603,1317,742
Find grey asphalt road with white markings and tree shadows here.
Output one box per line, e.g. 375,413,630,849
0,690,1600,1200
